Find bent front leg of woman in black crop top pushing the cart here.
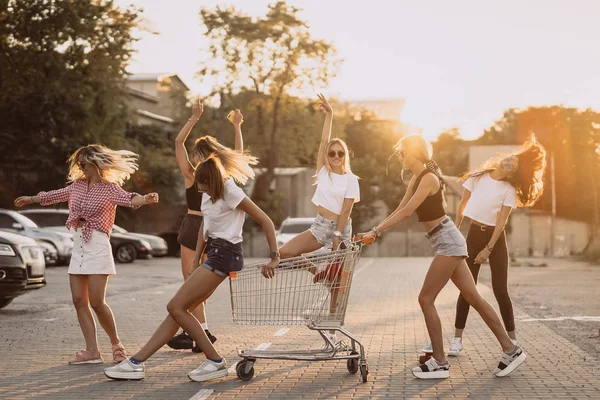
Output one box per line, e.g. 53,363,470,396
419,256,459,363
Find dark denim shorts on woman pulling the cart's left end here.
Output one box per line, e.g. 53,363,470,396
202,238,244,276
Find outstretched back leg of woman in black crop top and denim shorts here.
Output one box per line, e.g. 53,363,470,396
452,260,515,352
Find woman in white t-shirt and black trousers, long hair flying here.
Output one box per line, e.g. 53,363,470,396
448,136,546,356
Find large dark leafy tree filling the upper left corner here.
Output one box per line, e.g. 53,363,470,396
0,0,138,206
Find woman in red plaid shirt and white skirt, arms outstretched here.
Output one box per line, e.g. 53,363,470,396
15,144,158,364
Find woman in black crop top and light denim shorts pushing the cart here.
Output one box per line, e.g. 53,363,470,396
361,135,526,379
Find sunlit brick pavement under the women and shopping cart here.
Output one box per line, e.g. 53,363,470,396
0,258,600,400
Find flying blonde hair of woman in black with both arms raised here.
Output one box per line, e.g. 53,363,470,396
192,135,258,185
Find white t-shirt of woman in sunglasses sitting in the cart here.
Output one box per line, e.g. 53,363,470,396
312,167,360,215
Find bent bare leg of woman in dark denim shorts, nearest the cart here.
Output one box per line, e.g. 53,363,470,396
168,267,225,360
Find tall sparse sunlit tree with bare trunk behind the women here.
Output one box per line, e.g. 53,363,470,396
199,1,337,202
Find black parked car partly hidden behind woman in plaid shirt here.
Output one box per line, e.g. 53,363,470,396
21,208,152,263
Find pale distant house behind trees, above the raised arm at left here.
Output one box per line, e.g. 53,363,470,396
127,73,190,130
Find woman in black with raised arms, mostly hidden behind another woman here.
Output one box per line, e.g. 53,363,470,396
167,100,244,353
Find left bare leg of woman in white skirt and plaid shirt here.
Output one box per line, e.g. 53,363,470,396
69,274,99,354
